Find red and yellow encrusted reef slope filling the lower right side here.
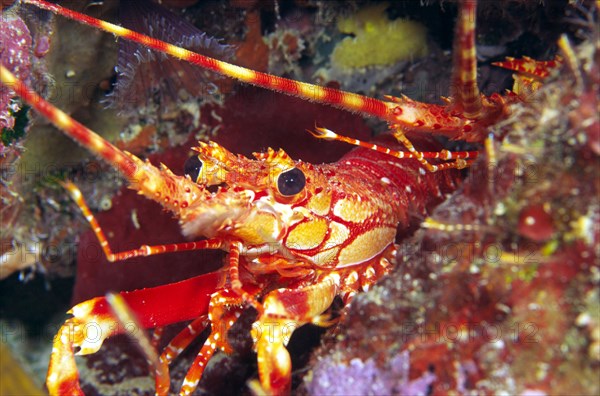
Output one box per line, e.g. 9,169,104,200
305,25,600,395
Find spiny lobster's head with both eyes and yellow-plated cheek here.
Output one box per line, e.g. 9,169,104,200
129,138,399,274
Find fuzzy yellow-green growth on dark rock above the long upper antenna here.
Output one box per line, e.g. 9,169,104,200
331,3,427,69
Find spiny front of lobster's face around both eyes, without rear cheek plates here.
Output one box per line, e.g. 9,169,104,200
171,142,324,250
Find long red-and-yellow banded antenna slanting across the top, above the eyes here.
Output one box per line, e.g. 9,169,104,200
23,0,396,119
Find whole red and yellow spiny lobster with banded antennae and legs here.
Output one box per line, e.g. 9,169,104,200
1,0,557,394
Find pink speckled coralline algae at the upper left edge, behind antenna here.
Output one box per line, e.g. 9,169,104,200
0,13,32,129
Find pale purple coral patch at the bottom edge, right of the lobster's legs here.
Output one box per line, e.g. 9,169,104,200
306,351,436,396
